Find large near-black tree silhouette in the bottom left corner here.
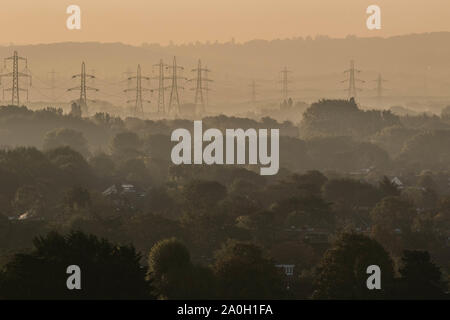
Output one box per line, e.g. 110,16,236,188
0,232,152,299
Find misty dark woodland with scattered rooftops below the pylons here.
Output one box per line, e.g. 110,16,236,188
0,100,450,299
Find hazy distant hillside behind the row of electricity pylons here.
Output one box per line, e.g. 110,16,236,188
0,32,450,111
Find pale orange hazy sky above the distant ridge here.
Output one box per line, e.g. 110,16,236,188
0,0,450,44
